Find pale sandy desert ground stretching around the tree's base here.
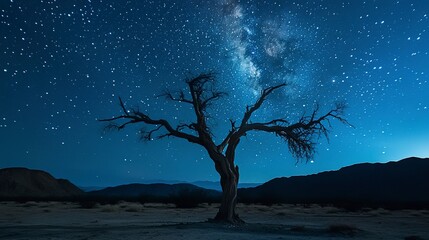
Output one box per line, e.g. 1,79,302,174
0,202,429,240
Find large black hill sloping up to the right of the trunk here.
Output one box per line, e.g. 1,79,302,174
239,157,429,206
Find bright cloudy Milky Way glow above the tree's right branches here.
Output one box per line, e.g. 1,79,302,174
224,2,317,97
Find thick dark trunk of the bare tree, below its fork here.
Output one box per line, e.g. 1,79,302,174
214,161,244,224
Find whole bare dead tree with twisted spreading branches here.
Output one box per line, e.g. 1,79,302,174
100,73,348,223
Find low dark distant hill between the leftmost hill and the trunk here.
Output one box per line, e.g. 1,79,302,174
88,183,220,199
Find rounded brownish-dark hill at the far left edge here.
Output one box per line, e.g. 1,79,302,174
0,168,83,199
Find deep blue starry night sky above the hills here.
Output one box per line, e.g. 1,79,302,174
0,0,429,186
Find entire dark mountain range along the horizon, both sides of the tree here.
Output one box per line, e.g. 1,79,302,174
0,157,429,207
